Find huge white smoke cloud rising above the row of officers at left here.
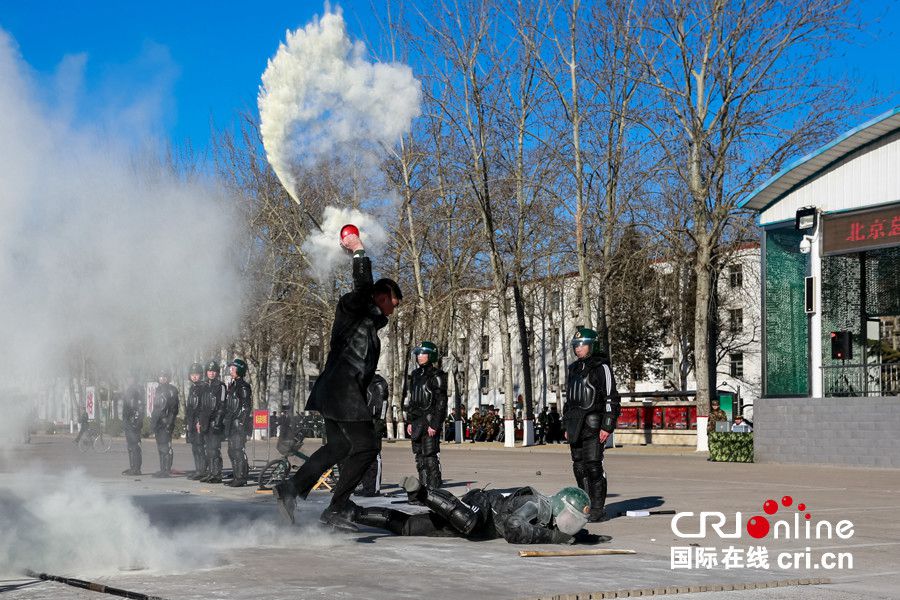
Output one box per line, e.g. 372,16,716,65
0,29,243,439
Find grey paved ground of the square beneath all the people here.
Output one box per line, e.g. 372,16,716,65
0,436,900,600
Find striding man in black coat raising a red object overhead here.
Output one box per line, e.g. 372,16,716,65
273,234,403,531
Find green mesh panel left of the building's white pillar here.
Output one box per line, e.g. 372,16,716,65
765,230,809,396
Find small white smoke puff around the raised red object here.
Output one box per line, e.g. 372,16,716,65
302,206,388,281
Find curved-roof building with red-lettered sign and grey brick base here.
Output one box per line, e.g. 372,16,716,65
742,109,900,467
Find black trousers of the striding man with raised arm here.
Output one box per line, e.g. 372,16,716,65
293,419,378,510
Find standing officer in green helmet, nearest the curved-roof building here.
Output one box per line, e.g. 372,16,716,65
563,327,620,522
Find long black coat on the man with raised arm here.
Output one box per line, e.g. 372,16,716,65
306,256,387,421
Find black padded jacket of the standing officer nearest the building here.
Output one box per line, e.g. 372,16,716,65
563,356,621,443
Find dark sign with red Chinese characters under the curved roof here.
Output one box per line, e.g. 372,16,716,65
822,202,900,255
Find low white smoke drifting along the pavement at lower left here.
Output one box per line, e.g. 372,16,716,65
0,471,342,577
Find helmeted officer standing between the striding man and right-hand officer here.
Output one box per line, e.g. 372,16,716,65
406,340,447,489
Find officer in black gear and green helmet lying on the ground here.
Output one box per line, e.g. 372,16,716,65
348,477,600,544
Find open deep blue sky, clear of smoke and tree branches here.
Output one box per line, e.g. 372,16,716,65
0,0,900,155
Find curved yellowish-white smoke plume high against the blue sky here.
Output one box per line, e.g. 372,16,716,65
259,7,422,198
